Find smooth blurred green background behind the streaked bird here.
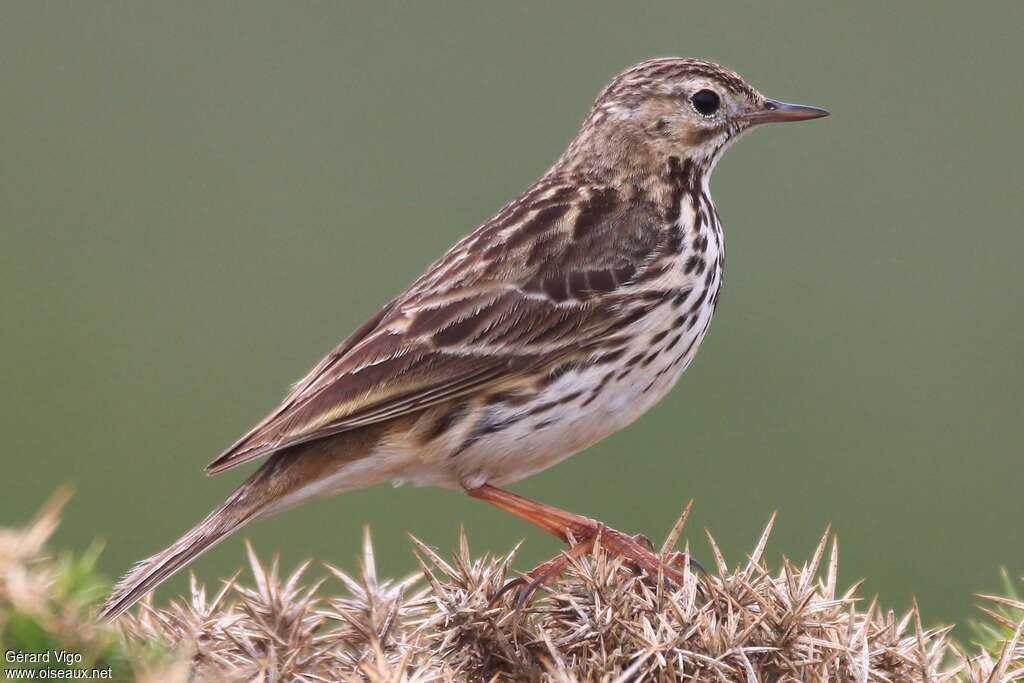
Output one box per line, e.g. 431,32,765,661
0,1,1024,623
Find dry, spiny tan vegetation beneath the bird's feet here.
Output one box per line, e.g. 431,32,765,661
0,493,1024,682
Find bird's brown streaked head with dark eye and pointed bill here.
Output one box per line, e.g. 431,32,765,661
570,57,828,178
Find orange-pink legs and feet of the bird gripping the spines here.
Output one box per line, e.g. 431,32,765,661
466,484,683,606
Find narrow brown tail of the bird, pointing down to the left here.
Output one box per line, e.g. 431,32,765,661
99,459,278,620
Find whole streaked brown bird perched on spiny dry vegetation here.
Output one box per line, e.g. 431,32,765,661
100,57,828,620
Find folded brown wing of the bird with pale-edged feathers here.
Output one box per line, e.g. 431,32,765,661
207,183,681,473
